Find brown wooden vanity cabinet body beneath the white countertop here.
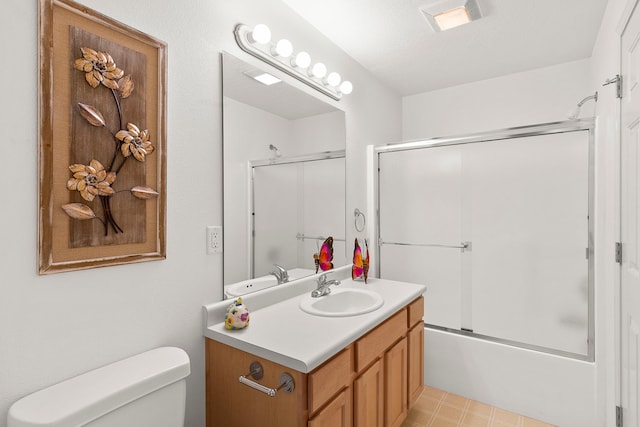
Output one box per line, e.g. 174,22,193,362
205,297,424,427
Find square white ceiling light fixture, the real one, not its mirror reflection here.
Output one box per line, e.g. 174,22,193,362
420,0,482,31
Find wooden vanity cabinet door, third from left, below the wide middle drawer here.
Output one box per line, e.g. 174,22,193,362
384,337,408,427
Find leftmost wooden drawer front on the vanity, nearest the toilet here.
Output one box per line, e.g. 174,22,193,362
307,347,353,413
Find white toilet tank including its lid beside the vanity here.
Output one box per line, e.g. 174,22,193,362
7,347,190,427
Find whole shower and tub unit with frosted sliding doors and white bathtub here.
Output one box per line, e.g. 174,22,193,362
368,120,597,427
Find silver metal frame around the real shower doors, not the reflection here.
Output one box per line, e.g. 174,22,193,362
367,118,596,362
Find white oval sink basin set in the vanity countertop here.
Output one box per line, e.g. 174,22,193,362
300,288,384,317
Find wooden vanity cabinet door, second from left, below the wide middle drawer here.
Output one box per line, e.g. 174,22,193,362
353,359,384,427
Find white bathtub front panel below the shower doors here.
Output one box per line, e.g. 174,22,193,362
424,327,599,427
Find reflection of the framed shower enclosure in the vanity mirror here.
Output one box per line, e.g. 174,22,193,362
247,150,347,278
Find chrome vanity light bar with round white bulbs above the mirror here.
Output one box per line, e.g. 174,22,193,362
233,24,353,101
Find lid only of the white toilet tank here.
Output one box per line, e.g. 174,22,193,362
7,347,190,427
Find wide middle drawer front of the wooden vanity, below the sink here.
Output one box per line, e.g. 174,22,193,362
356,308,407,372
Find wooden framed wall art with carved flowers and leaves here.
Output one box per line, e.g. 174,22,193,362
38,0,167,274
